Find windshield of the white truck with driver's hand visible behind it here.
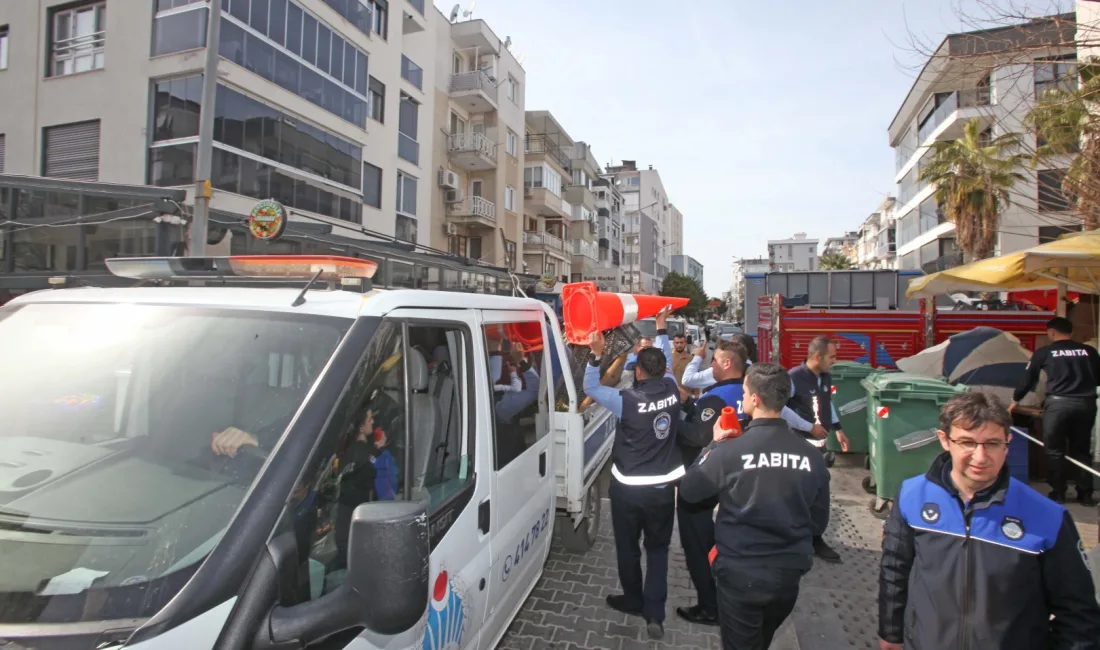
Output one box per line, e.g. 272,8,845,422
0,304,352,624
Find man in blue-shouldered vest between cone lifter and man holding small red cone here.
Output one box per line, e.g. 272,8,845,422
677,341,748,625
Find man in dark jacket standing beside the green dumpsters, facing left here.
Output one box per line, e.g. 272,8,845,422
785,337,848,563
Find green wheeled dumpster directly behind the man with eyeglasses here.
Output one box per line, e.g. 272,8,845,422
860,373,968,518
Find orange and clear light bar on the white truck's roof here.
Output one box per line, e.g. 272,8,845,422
107,255,378,280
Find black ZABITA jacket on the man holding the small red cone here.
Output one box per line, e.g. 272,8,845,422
680,418,829,571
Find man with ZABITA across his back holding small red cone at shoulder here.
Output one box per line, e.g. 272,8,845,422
680,363,829,650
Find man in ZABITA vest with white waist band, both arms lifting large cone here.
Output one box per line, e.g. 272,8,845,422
584,307,684,639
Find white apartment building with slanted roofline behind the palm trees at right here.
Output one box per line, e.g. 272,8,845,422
888,14,1077,273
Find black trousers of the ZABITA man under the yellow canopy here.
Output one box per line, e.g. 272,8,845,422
1043,396,1097,495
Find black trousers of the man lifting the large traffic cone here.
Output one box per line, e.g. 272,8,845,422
608,478,677,621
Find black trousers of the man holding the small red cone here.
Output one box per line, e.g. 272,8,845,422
714,555,804,650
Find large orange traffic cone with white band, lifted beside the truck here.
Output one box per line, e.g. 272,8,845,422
561,283,689,345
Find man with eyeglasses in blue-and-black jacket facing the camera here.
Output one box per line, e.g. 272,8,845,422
879,393,1100,650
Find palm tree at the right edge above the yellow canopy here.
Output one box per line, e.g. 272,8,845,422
1024,58,1100,230
